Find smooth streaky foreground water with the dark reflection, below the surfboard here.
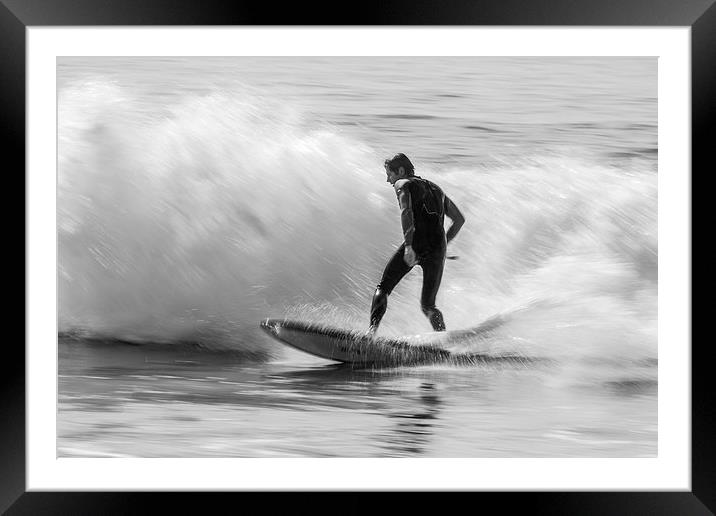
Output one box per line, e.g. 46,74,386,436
57,343,656,457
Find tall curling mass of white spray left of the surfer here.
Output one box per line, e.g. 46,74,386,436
58,80,399,345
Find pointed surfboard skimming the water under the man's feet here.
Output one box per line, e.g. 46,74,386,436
261,319,510,366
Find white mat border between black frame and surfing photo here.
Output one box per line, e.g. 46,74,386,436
26,27,691,491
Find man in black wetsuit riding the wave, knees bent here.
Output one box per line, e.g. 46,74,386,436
367,153,465,336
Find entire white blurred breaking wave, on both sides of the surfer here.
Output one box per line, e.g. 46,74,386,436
58,82,657,374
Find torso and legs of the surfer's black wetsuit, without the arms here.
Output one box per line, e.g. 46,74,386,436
370,176,447,331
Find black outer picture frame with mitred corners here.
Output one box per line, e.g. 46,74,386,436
5,0,716,515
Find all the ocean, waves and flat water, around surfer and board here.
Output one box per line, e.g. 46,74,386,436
57,57,658,457
